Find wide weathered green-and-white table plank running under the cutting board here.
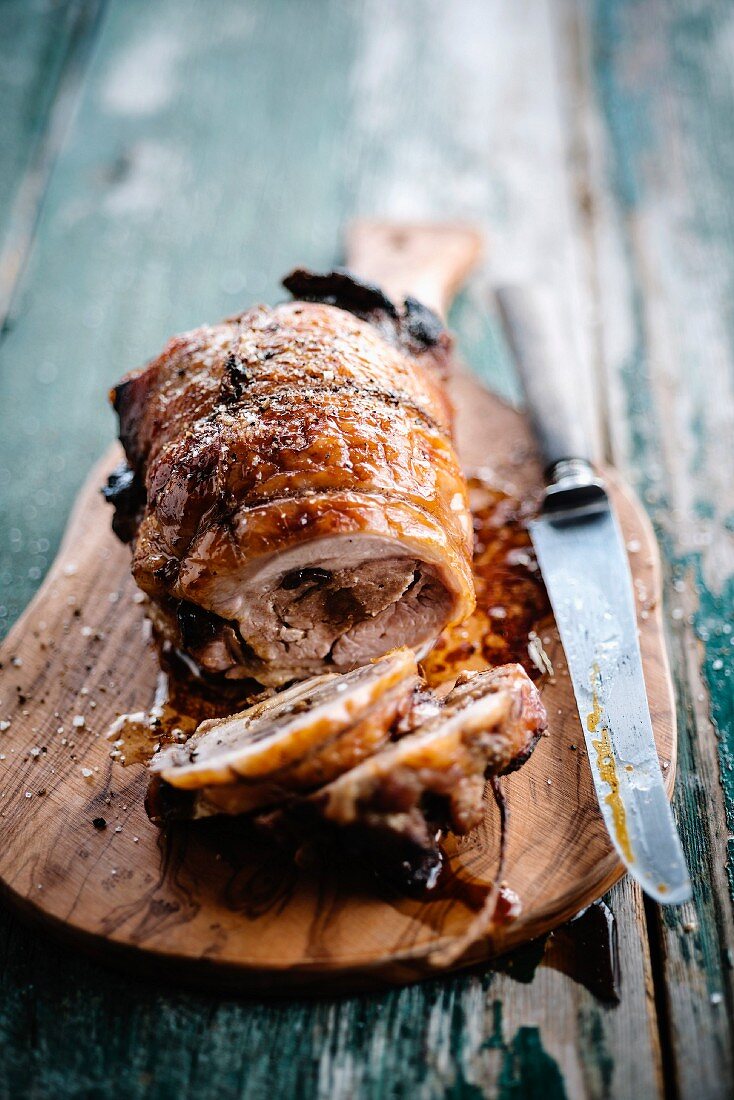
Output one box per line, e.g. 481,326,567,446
0,0,730,1097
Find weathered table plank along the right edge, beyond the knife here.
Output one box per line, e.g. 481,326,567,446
556,0,734,1097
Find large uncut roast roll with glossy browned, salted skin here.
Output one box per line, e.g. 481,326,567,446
108,272,474,686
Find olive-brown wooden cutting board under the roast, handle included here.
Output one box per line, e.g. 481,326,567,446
0,223,676,993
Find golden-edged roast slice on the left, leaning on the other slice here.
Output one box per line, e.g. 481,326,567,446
149,649,418,818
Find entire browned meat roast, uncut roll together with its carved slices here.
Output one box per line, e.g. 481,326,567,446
106,271,546,902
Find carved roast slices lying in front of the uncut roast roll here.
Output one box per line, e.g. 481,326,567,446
146,649,546,888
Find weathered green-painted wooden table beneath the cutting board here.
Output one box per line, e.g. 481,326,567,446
0,0,734,1100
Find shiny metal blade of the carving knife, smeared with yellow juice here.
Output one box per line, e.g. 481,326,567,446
530,501,691,904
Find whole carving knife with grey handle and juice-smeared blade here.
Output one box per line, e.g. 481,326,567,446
497,286,691,904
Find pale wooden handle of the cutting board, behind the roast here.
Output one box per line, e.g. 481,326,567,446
346,218,482,318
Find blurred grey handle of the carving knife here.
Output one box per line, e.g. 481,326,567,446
497,286,594,476
